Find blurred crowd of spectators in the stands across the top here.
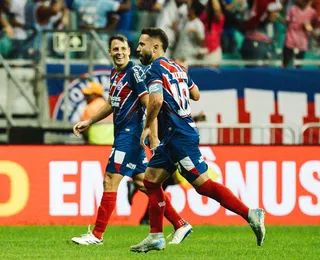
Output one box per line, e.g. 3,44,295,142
0,0,320,67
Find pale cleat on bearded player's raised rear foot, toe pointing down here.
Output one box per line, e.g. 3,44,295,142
248,209,266,246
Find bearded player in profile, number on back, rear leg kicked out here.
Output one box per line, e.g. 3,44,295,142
131,28,265,252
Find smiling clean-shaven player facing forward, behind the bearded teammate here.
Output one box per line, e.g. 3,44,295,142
72,35,192,245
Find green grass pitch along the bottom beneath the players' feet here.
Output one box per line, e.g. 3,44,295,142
0,226,320,260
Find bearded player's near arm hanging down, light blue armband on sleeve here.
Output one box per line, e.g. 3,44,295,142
140,83,163,148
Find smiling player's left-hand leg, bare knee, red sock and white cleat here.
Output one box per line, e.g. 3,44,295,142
72,172,123,245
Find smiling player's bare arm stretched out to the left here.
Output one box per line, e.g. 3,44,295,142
73,97,112,136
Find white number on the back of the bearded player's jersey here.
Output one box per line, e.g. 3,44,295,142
170,81,191,117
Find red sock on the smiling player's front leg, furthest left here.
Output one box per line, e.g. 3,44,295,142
92,192,117,239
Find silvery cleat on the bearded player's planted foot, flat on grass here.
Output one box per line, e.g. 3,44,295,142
130,233,166,253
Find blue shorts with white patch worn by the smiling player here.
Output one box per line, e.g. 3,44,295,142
106,134,148,177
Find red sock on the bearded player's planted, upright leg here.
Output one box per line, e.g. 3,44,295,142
143,179,166,233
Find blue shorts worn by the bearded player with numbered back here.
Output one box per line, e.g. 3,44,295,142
148,133,208,183
